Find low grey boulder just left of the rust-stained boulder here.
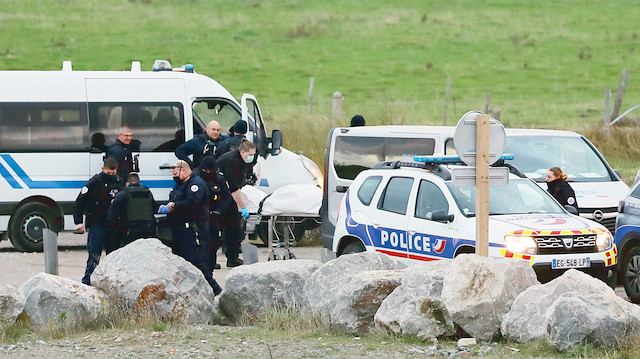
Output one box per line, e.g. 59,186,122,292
20,273,107,327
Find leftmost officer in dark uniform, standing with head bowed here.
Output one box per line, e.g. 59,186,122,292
73,157,125,285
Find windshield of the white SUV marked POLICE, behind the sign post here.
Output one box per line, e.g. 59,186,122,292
447,179,565,217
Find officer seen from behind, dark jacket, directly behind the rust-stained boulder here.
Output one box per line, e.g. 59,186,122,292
107,172,158,247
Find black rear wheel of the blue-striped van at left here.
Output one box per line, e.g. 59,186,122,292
9,202,57,252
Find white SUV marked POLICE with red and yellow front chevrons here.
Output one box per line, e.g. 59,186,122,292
332,158,616,285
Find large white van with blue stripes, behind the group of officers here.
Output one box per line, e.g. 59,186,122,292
0,61,322,251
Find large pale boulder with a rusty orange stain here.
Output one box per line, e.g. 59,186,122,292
91,238,214,323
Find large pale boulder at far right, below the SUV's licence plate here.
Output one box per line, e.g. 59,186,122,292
501,269,640,350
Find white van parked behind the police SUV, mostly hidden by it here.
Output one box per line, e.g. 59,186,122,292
320,126,629,248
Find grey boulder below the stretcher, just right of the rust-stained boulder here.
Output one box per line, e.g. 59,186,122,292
220,259,322,318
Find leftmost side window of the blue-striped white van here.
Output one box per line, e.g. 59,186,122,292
0,103,89,152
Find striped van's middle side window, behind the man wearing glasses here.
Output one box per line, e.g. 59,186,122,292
89,103,184,152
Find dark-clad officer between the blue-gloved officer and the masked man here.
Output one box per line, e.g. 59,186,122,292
198,156,238,269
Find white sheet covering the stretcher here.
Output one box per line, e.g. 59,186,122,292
242,184,322,217
